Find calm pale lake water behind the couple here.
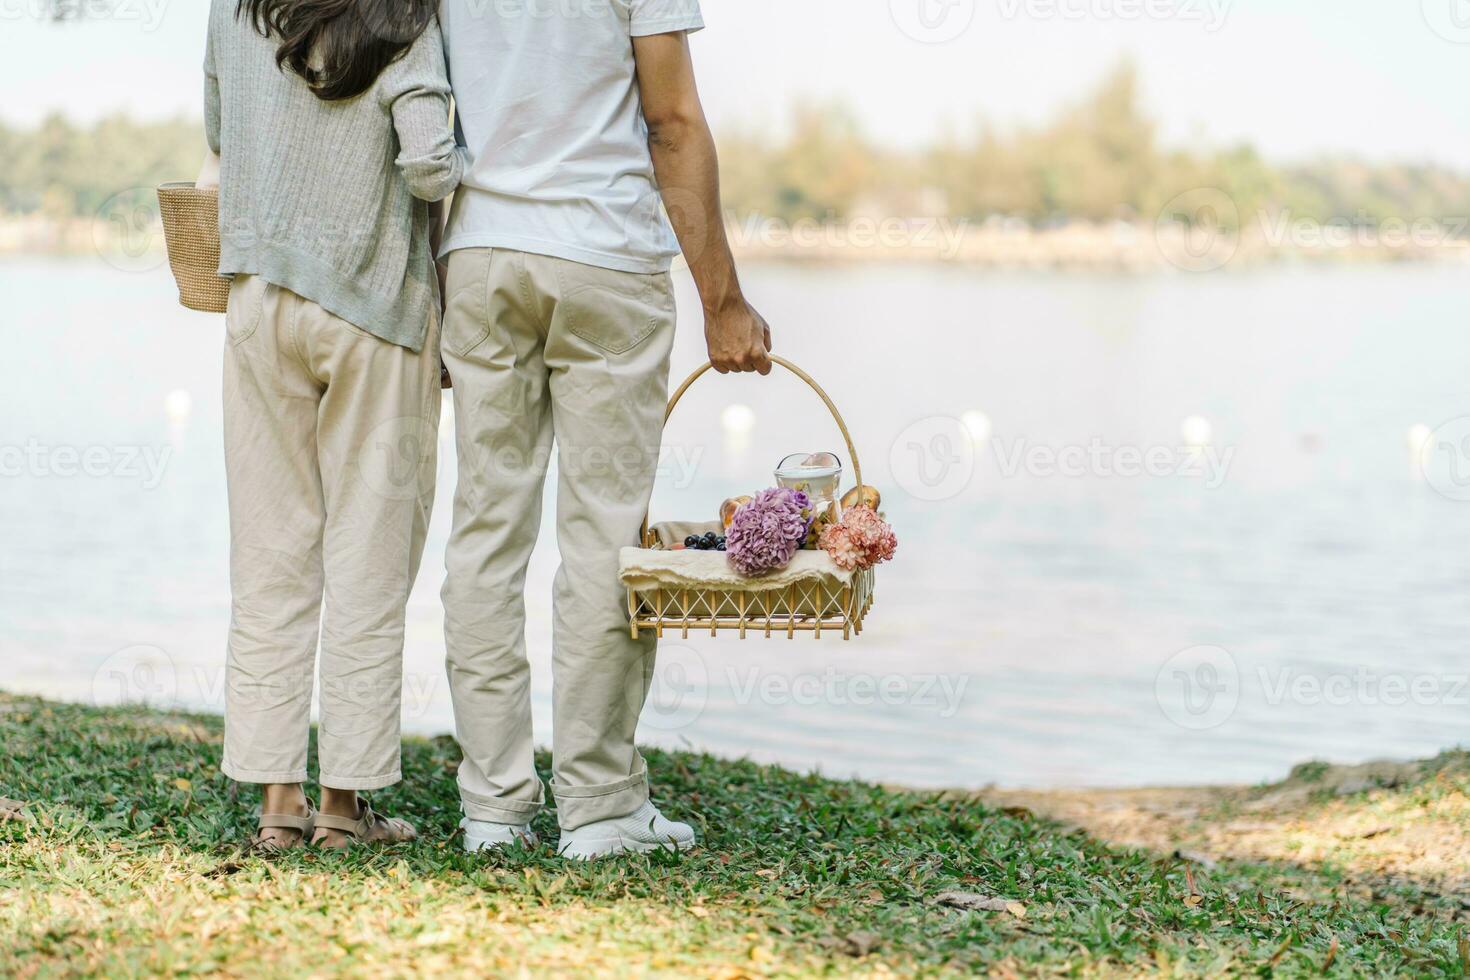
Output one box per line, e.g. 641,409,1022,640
0,259,1470,786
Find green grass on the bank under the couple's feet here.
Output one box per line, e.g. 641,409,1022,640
0,695,1470,977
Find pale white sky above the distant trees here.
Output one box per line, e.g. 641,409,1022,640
0,0,1470,170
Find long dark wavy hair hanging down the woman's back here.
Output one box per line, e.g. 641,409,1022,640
235,0,438,101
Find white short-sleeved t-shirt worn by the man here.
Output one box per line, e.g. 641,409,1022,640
440,0,704,273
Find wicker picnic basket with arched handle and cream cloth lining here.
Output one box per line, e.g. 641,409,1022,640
625,354,875,639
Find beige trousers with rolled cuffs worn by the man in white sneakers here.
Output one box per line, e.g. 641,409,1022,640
444,248,675,830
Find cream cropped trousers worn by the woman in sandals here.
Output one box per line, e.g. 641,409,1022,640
223,276,440,789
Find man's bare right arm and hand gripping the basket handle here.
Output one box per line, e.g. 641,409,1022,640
634,34,770,375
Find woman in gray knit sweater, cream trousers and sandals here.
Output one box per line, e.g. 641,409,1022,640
204,0,465,851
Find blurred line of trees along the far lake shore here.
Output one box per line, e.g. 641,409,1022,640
0,65,1470,233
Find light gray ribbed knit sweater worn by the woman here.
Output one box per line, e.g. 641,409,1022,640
204,0,466,351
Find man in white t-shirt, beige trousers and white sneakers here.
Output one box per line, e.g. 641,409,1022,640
440,0,770,858
